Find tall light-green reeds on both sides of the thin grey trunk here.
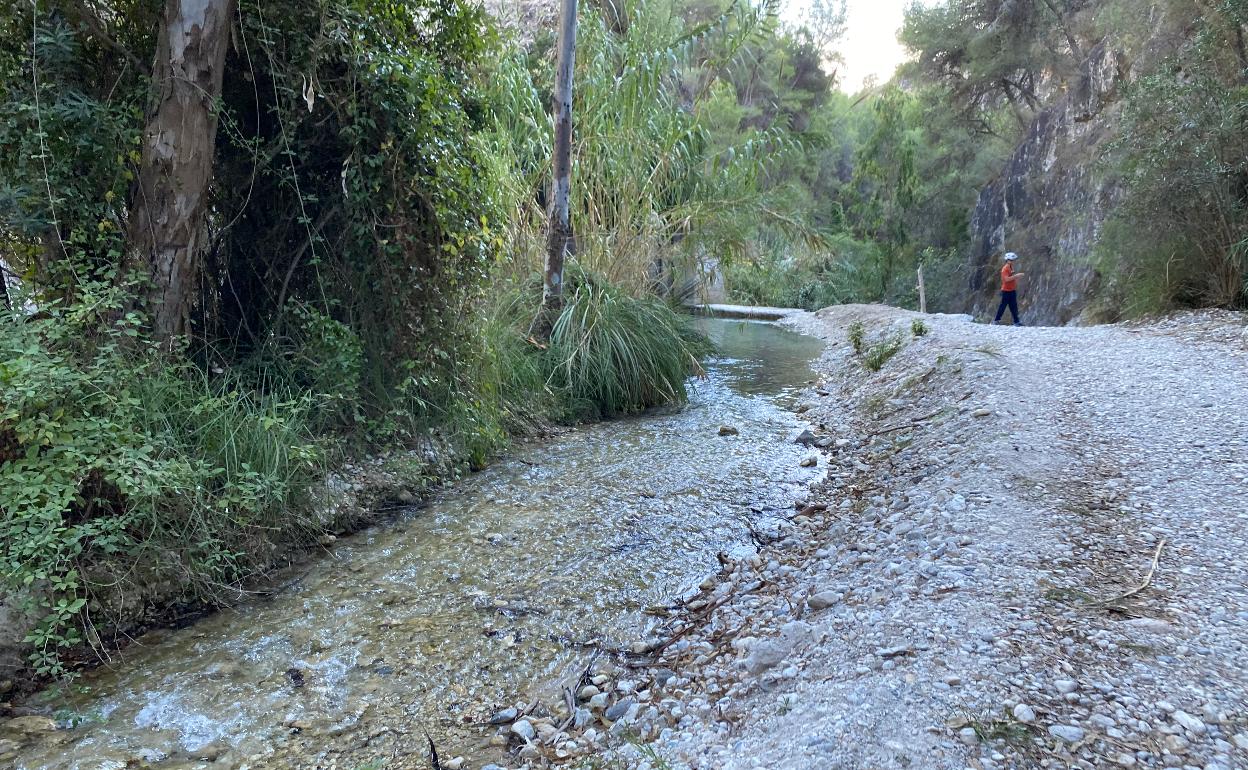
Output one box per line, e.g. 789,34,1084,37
488,0,795,295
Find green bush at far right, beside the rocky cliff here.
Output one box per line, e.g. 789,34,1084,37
1098,0,1248,316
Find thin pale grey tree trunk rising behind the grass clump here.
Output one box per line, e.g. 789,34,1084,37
538,0,577,336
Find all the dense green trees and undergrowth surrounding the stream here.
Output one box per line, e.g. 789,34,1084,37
0,0,1248,674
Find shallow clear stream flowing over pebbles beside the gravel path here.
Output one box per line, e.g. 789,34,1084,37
12,321,821,770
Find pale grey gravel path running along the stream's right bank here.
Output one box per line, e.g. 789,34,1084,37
574,306,1248,770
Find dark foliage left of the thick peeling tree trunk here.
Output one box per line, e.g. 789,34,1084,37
0,4,147,298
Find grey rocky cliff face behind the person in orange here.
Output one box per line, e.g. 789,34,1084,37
966,42,1128,324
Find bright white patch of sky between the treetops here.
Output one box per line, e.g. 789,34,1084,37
780,0,911,94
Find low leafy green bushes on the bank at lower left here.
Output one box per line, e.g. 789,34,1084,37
0,281,322,674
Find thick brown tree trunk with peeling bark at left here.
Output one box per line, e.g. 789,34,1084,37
129,0,235,342
